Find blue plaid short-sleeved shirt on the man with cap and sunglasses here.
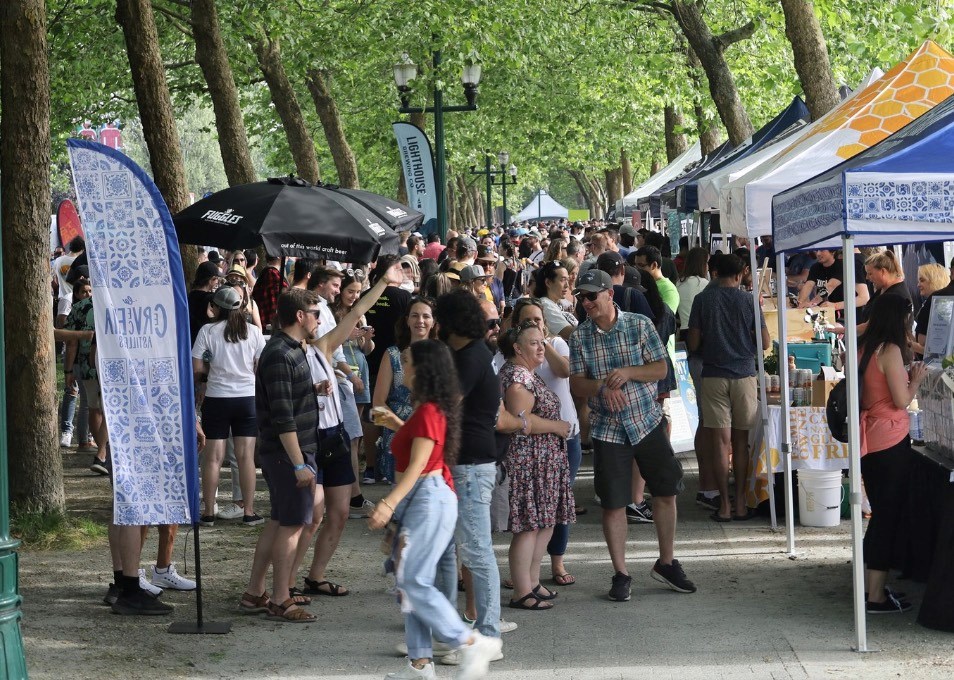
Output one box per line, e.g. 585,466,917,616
570,307,666,445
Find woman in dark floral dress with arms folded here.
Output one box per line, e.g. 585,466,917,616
500,323,575,610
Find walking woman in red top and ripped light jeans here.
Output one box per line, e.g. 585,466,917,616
368,340,501,680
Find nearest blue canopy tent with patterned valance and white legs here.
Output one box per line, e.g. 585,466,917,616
772,91,954,651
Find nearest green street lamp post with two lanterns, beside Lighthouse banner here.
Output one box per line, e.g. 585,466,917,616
394,50,480,240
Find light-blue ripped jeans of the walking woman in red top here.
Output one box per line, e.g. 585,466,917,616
397,477,471,659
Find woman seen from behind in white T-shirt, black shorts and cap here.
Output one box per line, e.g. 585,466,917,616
192,286,265,526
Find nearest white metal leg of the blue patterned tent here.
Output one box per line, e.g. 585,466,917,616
841,234,868,652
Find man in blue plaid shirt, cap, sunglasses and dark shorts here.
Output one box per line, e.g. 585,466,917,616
570,269,696,602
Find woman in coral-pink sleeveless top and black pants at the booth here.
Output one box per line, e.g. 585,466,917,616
858,295,924,614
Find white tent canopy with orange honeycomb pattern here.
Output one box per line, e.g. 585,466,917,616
722,40,954,238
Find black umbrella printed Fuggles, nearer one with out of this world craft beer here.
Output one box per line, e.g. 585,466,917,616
173,177,399,263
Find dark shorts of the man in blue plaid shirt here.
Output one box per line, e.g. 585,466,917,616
593,420,683,510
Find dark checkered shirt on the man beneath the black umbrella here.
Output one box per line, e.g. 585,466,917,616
255,331,318,457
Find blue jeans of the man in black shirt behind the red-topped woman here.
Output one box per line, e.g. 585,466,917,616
451,463,500,637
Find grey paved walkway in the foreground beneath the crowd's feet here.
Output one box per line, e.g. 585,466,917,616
21,448,954,680
